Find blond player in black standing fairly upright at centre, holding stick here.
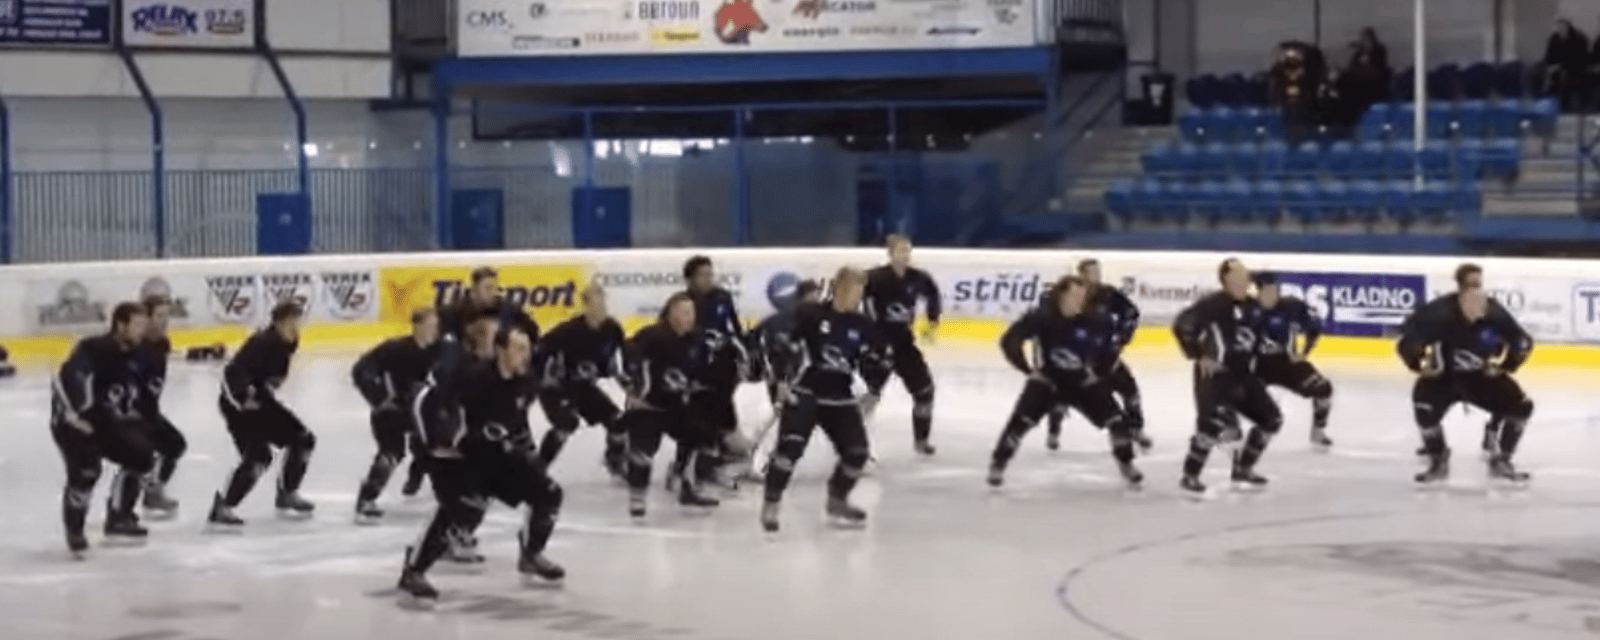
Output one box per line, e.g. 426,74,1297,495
762,267,890,531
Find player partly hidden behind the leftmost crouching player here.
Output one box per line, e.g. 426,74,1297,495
134,296,189,518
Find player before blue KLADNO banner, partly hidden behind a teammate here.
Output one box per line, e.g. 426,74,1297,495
1254,274,1333,450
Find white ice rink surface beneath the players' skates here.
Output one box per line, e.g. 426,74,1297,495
0,347,1600,640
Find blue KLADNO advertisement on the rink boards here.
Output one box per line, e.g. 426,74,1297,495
1275,272,1427,336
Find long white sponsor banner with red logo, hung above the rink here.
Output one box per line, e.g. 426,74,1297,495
456,0,1038,56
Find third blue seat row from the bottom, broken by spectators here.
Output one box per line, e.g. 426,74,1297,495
1178,98,1560,142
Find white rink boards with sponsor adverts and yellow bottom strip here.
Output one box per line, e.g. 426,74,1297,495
0,248,1600,368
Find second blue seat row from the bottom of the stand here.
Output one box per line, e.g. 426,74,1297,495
1141,139,1522,179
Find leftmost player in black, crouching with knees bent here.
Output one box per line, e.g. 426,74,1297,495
50,302,155,558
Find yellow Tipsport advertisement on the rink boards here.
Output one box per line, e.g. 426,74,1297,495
379,264,589,330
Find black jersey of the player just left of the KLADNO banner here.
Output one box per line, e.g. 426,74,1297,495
1173,291,1261,373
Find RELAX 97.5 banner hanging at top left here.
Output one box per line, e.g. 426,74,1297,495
123,0,256,48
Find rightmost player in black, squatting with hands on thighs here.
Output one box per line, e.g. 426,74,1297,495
1397,290,1533,483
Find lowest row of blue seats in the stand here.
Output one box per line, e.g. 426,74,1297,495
1106,178,1483,222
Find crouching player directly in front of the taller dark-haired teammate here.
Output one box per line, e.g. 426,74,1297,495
621,293,718,518
